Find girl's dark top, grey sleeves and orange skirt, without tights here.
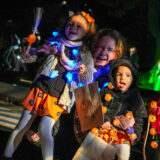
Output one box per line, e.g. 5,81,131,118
22,34,93,120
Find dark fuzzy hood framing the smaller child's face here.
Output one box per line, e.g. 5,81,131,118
109,57,138,89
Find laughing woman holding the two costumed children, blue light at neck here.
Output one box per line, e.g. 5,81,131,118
74,28,127,143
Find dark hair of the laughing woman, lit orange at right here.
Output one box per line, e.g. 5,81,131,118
92,28,127,58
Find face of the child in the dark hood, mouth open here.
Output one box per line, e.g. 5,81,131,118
115,66,133,92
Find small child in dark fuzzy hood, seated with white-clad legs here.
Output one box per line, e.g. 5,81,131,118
73,58,147,160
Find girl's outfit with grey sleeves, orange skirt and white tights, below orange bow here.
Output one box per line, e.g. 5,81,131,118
4,31,93,159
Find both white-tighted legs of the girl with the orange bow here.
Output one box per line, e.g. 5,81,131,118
4,110,55,160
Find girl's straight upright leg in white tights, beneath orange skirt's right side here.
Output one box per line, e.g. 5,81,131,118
39,116,55,160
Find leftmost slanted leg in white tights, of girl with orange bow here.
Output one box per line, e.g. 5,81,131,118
4,110,36,157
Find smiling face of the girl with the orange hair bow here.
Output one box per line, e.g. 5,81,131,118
65,15,88,41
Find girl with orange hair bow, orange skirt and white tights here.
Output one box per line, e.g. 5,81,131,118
4,12,95,160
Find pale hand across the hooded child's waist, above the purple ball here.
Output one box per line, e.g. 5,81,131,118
115,115,135,129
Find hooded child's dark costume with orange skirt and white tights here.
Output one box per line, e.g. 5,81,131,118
73,58,147,160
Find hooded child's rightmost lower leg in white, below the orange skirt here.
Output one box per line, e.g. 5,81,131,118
115,144,130,160
